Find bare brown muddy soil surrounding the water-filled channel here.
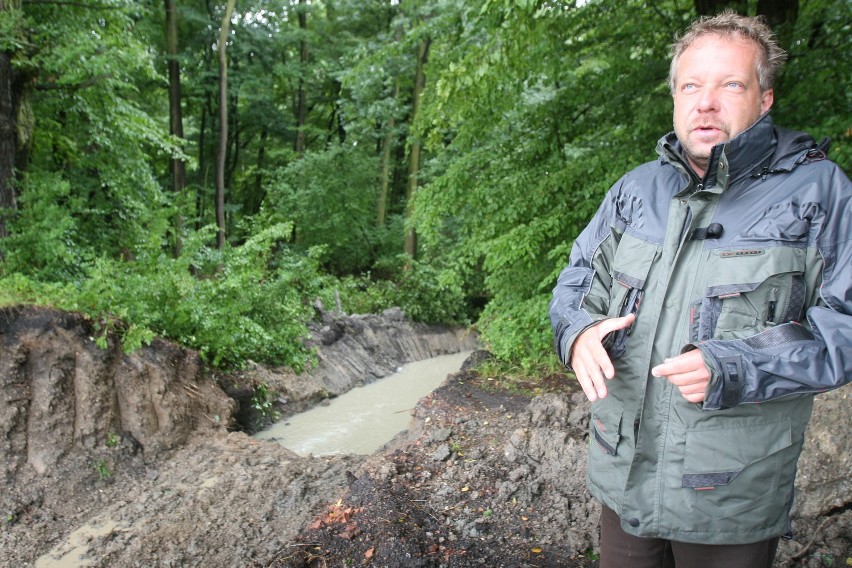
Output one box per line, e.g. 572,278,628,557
0,308,852,568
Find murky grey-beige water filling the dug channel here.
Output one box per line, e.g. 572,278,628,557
255,351,471,456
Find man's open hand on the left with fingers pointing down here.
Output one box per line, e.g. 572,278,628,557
571,314,636,402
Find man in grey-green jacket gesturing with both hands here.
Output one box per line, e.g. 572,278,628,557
550,12,852,568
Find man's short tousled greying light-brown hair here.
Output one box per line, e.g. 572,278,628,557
669,10,787,93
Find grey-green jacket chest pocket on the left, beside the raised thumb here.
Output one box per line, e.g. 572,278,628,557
605,234,660,357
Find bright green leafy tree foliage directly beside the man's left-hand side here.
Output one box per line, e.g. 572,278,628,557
416,2,670,364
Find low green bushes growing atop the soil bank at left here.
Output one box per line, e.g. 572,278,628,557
0,225,324,370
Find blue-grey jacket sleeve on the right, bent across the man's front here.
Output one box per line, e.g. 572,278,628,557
696,164,852,410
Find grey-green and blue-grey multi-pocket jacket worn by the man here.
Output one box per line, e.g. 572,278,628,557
550,115,852,544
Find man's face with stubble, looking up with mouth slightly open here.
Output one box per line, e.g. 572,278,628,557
673,35,773,175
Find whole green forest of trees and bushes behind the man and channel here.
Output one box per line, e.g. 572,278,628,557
0,0,852,373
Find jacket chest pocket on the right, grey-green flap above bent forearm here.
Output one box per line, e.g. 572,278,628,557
690,247,807,342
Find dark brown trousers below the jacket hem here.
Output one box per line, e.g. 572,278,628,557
600,506,778,568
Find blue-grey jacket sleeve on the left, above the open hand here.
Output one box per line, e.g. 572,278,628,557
549,178,623,370
